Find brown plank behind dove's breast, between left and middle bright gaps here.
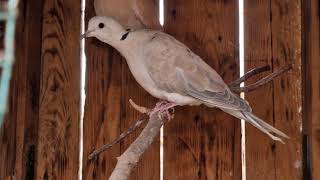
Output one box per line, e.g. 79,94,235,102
83,1,160,180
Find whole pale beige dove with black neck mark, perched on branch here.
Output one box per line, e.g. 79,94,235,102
80,16,289,143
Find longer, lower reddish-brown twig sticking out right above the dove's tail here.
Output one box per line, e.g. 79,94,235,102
229,64,292,93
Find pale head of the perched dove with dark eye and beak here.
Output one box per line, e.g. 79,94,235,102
81,16,126,44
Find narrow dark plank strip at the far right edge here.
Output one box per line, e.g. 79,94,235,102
302,1,320,179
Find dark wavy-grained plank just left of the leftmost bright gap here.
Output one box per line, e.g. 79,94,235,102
36,0,81,179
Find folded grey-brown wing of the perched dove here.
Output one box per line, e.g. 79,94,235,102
144,32,251,111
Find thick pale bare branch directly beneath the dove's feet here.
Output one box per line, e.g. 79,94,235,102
109,113,165,180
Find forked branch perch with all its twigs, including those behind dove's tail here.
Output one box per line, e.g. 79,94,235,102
89,64,292,180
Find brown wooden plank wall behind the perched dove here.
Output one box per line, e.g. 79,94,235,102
0,0,320,180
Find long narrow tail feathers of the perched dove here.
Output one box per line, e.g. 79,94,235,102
222,109,290,144
